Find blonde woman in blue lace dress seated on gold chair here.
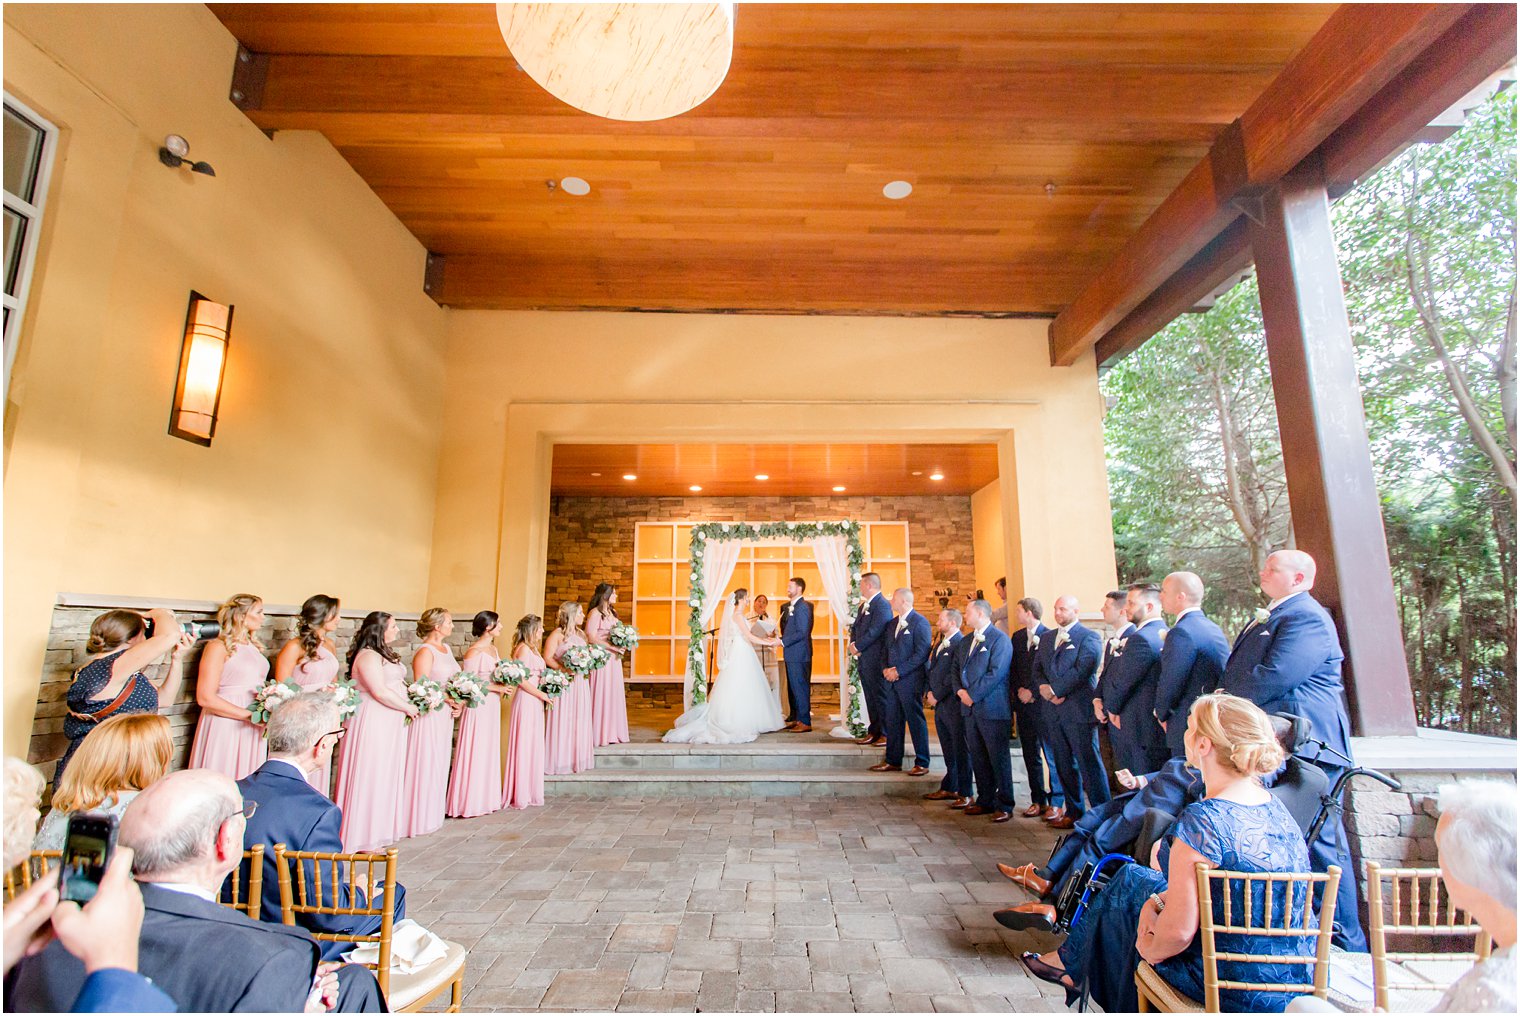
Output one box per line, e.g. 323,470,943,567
1021,695,1315,1013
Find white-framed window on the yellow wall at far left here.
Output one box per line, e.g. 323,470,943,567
5,96,58,401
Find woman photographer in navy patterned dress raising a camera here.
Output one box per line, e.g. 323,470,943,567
53,608,195,786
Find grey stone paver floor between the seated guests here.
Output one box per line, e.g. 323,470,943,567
401,785,1064,1011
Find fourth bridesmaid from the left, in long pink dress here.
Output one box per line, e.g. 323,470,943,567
401,607,462,837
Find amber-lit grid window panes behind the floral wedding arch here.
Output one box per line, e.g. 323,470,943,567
631,522,909,683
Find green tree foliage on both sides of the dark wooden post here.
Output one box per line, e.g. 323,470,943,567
1104,91,1517,736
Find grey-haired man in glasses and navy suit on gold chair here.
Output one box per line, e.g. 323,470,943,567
234,692,407,960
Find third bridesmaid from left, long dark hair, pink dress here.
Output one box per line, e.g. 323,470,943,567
333,610,416,852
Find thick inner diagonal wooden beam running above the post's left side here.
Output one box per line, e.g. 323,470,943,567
1050,3,1471,365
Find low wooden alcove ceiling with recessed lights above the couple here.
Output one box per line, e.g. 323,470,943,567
550,444,997,497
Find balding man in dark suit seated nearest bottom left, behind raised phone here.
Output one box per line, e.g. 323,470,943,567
6,770,385,1013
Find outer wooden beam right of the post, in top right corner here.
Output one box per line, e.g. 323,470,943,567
1321,3,1515,190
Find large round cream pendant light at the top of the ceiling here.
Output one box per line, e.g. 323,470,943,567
496,3,734,120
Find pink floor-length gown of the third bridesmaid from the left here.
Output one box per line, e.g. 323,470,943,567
333,649,409,850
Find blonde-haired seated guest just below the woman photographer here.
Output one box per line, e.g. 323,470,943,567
32,713,175,850
